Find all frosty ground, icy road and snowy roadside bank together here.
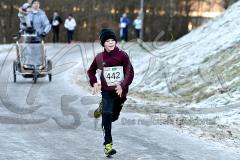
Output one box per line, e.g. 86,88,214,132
0,2,240,160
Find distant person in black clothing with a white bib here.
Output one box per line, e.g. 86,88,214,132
50,11,62,43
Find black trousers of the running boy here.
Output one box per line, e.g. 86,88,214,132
102,91,126,145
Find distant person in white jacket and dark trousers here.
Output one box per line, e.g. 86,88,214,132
64,14,77,43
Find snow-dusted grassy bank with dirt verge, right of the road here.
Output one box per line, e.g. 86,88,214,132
126,2,240,149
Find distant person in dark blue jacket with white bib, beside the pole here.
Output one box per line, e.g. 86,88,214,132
119,13,130,42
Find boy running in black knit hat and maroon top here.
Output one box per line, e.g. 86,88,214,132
88,29,134,156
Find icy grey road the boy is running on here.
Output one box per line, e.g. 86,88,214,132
0,43,240,160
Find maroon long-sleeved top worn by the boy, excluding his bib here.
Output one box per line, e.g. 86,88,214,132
87,47,134,96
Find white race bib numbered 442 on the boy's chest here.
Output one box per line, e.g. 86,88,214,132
103,66,124,86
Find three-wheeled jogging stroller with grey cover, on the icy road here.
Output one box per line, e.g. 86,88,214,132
13,33,52,83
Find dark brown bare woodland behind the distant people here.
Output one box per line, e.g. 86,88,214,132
0,0,229,43
